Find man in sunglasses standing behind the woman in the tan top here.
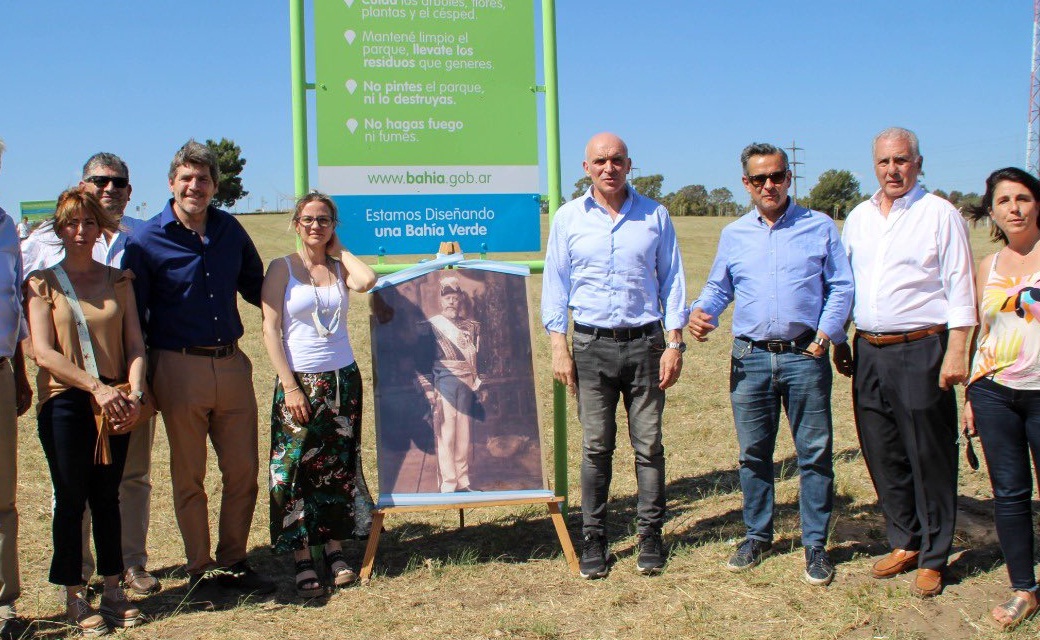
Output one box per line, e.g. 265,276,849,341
22,153,160,595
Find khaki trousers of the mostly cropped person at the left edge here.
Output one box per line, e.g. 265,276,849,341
0,358,22,607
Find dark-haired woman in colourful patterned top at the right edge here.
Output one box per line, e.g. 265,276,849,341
963,168,1040,631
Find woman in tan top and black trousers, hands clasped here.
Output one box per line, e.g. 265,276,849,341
28,188,146,635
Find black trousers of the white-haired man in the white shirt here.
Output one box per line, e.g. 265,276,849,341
853,333,957,569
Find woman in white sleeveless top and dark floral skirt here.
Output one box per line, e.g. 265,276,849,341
262,194,375,597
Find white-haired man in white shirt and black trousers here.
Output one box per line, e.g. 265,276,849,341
834,128,976,597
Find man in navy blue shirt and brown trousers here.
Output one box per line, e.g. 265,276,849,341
125,139,275,593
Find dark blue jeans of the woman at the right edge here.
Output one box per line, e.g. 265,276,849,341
968,379,1040,591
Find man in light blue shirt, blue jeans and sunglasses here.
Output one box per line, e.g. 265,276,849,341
688,143,853,585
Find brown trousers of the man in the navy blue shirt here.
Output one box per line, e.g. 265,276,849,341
151,350,260,575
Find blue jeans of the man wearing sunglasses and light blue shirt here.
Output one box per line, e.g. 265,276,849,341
729,338,834,546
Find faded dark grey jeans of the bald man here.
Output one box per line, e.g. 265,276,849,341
572,331,665,535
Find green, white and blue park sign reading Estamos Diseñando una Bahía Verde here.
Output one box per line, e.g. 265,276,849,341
314,0,540,254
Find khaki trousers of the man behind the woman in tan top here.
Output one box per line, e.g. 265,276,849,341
83,418,155,582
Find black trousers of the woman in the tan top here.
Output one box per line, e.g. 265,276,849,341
36,389,130,586
